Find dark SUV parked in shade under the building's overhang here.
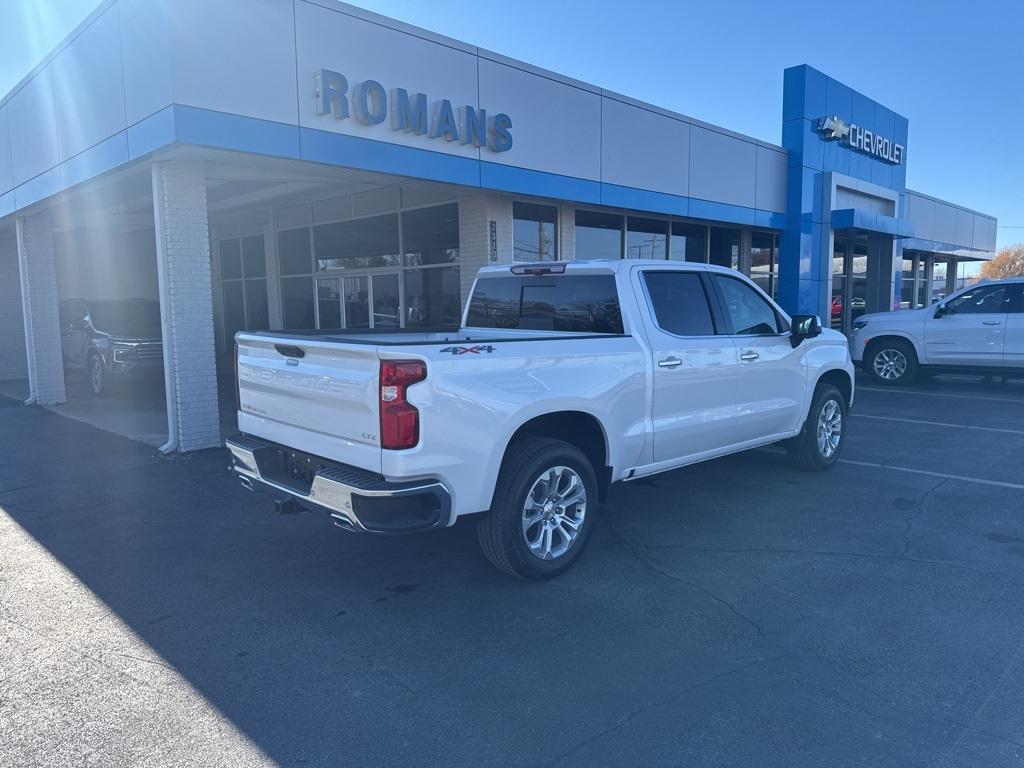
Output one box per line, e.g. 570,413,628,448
60,299,164,395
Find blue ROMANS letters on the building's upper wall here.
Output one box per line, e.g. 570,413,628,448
314,70,512,152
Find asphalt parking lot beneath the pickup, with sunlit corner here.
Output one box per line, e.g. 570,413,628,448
0,378,1024,768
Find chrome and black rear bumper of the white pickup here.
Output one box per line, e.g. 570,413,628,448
225,436,452,534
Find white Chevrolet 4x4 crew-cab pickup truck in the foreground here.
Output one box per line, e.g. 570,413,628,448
227,260,854,580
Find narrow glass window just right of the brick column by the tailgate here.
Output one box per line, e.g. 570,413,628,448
220,234,270,348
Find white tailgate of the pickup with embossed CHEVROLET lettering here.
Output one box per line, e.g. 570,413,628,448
237,333,381,472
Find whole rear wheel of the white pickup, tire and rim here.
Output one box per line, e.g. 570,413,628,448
476,437,597,582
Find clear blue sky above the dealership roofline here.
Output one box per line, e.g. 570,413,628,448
0,0,1024,246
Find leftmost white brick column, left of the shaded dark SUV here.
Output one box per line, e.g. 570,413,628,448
17,214,66,406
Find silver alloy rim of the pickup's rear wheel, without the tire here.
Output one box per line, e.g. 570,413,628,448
522,466,587,560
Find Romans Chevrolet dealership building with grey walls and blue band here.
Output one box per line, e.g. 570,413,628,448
0,0,996,451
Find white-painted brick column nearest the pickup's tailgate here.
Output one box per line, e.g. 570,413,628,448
153,158,220,452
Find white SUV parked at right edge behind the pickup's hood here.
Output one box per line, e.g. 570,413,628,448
850,278,1024,384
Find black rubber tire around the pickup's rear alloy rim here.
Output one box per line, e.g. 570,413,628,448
476,437,598,582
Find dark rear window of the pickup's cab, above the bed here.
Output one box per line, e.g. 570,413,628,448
466,274,623,334
